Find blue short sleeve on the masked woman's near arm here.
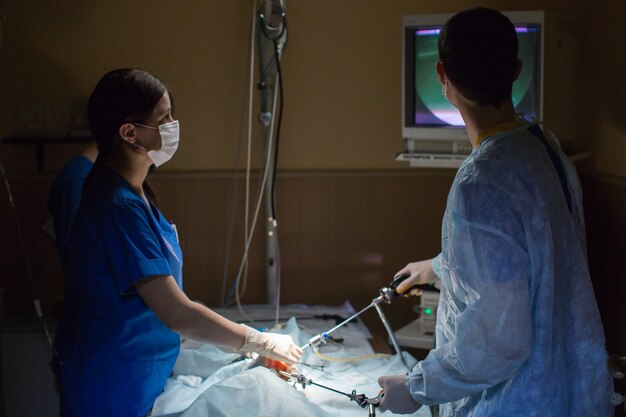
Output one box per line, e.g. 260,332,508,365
103,200,172,294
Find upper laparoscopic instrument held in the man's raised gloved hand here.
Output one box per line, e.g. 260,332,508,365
301,274,430,362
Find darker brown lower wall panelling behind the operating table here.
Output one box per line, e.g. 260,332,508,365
0,170,453,324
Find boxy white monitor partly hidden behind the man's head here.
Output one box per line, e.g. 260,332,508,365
402,11,544,150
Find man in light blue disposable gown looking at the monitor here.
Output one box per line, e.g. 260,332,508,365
379,8,613,417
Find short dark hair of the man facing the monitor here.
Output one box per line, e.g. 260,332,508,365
438,7,518,108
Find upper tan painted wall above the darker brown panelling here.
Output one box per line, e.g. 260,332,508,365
0,0,584,175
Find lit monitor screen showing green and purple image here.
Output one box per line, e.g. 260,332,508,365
403,11,542,137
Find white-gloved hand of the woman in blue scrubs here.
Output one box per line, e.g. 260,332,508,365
239,324,302,363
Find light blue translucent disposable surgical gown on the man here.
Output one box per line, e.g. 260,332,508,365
406,123,613,417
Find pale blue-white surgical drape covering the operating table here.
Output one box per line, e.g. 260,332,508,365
152,306,431,417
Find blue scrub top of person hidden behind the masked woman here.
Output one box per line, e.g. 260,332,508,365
48,155,93,275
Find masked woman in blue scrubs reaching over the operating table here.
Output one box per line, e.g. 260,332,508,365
55,69,302,417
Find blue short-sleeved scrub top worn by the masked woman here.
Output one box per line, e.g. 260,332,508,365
55,167,182,417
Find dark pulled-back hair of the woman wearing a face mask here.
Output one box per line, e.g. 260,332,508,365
87,68,167,156
